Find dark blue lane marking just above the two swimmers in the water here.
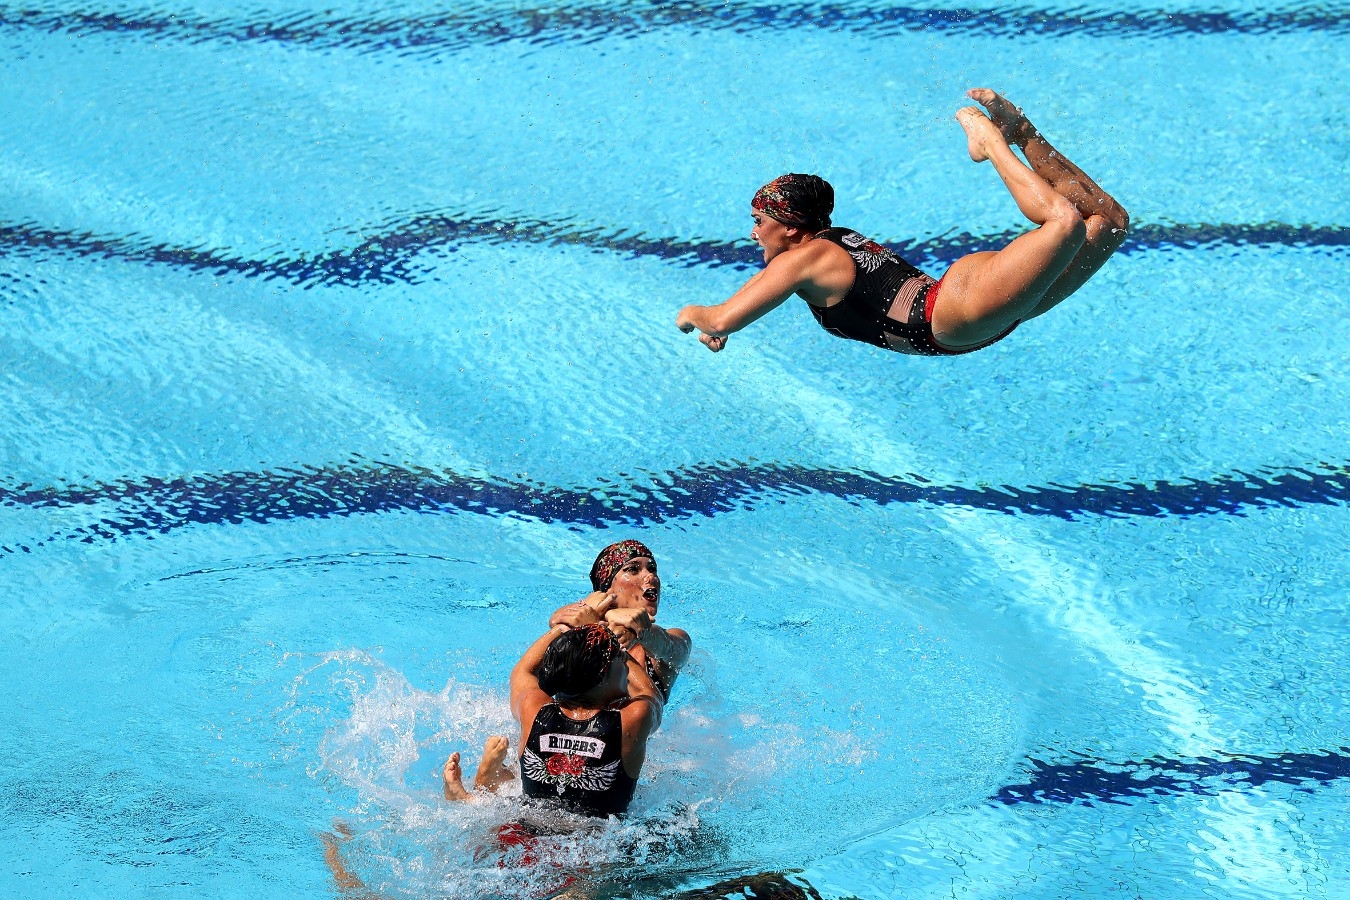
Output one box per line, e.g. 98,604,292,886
0,460,1350,552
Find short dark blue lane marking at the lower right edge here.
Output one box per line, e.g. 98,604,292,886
990,748,1350,806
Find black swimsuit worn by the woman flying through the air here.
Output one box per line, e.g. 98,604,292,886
807,228,1015,356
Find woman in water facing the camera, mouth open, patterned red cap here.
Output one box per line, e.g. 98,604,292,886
548,540,694,700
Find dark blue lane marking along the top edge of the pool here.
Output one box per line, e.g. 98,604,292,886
0,0,1350,58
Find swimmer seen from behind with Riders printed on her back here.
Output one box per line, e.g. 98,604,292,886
443,623,664,818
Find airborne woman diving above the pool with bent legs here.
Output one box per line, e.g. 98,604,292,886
675,88,1130,356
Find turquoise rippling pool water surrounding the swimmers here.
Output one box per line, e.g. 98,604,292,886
0,3,1350,900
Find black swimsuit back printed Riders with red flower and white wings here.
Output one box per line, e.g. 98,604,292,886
520,703,637,816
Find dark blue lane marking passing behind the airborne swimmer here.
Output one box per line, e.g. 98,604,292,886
0,215,1350,287
